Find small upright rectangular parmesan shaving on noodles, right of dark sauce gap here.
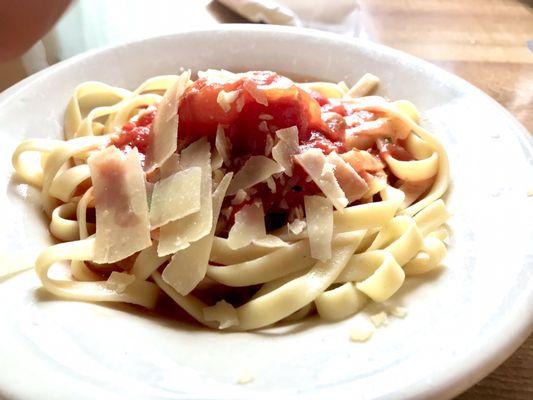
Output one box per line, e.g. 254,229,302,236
304,196,333,261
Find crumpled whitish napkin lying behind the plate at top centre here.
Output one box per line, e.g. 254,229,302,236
218,0,358,34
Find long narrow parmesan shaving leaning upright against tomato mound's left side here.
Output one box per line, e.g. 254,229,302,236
145,71,191,172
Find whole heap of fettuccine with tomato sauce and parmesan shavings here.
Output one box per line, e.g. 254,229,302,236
12,70,448,331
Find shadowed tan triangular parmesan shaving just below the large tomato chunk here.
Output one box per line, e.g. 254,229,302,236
228,156,283,196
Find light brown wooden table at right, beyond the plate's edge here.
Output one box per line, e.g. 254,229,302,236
359,0,533,400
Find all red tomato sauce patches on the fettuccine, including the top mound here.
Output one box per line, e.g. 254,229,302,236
112,71,394,228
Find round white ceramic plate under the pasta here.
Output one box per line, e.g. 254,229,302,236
0,25,533,400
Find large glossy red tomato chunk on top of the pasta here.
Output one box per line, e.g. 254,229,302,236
178,71,328,157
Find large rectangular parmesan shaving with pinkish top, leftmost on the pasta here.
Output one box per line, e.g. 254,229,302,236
88,146,152,263
